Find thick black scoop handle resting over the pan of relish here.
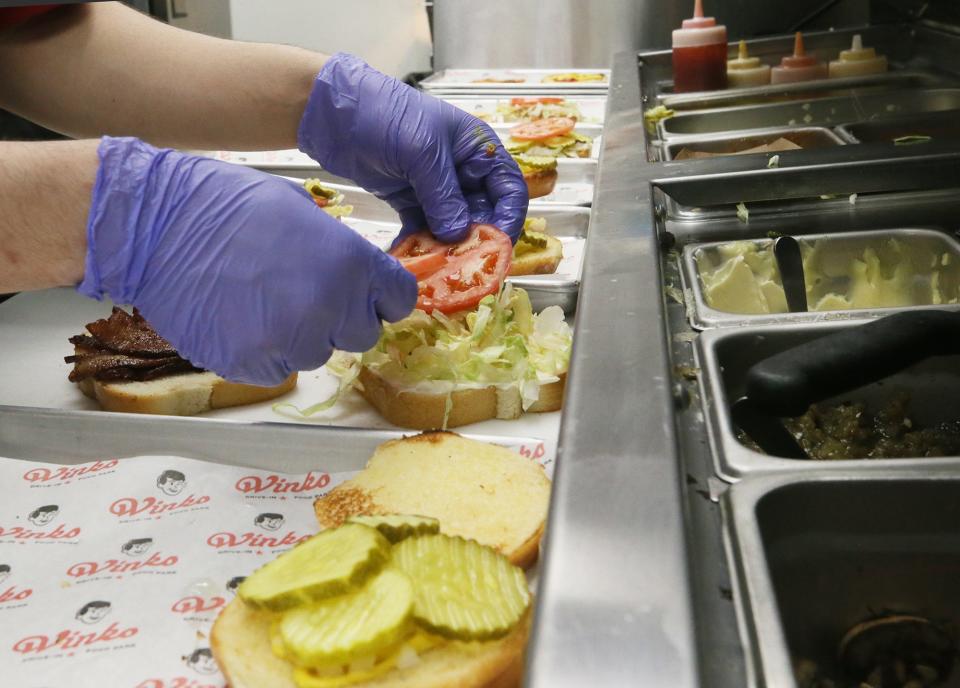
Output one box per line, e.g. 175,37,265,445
746,311,960,417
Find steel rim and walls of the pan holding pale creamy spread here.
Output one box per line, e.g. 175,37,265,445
683,229,960,329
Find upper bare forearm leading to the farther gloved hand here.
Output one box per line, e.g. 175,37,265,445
0,2,326,150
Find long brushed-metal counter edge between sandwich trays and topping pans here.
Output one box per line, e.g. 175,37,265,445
527,53,699,688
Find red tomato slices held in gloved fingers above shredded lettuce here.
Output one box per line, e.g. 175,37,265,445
390,225,513,313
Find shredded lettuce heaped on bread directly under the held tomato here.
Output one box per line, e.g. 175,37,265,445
283,284,573,416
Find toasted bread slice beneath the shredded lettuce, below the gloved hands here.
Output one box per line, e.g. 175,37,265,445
357,366,567,430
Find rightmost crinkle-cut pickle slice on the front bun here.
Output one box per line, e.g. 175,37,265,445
393,535,530,640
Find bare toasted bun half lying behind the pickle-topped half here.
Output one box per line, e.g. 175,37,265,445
314,432,550,568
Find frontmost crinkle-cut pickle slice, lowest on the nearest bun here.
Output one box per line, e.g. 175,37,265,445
278,569,414,667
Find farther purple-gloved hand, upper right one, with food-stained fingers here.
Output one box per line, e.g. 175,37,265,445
297,53,528,247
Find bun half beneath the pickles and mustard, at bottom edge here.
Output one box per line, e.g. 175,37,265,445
210,600,530,688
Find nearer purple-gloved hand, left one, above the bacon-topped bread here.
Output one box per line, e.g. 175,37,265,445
77,137,417,385
